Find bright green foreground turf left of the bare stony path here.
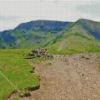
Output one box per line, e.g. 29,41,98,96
0,49,39,100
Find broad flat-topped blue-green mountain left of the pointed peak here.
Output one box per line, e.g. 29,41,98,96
0,20,72,48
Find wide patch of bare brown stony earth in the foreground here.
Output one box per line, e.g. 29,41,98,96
8,53,100,100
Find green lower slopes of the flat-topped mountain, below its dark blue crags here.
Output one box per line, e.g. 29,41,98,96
13,23,72,48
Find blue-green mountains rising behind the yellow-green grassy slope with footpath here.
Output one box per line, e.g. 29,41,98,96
0,19,100,49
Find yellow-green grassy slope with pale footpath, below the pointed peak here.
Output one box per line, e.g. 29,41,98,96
45,33,100,54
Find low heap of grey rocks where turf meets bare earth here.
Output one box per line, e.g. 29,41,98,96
28,48,53,58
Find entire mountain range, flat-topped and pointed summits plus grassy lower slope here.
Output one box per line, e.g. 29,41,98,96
0,19,100,54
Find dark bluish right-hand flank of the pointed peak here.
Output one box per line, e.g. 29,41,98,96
77,19,100,40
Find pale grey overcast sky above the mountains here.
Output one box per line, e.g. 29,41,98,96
0,0,100,31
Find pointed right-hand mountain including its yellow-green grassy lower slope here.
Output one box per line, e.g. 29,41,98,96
46,19,100,54
